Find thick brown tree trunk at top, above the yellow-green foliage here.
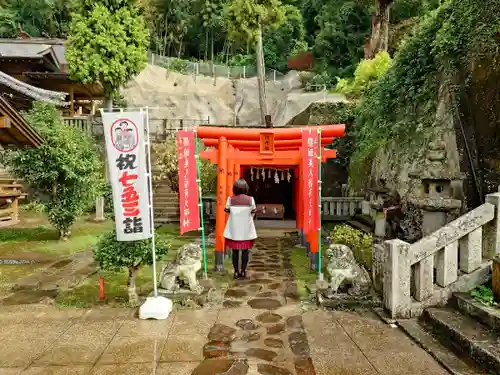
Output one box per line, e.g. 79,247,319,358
365,0,394,59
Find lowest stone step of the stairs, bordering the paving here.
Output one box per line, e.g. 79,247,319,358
398,319,488,375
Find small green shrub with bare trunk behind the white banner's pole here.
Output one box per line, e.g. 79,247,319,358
93,231,171,306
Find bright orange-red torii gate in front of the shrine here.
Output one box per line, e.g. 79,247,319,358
196,125,345,270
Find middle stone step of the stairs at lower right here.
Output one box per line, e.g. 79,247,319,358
424,307,500,374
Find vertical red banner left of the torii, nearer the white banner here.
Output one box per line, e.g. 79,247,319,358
177,130,200,235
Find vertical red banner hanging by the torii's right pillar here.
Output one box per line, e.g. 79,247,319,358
301,128,320,234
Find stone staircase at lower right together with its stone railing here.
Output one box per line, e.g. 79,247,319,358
373,193,500,375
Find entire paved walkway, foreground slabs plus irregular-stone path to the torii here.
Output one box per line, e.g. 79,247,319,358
0,238,447,375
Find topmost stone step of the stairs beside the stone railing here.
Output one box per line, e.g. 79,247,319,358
452,293,500,333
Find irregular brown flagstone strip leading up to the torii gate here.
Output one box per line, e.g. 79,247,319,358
192,238,315,375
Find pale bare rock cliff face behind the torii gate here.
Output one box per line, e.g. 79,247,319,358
122,65,348,134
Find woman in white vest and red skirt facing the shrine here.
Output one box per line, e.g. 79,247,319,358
224,178,257,279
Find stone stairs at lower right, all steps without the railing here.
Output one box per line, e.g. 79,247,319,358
398,293,500,375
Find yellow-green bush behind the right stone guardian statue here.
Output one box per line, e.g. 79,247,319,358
330,224,373,270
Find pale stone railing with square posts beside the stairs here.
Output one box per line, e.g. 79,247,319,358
383,193,500,318
